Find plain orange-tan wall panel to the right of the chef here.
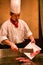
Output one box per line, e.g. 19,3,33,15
21,0,39,38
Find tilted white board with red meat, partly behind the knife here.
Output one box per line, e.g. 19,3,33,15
24,42,41,59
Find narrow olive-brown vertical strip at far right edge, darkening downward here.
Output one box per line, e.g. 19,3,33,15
39,0,43,52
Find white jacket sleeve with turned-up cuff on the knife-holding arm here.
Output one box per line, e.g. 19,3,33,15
0,24,8,44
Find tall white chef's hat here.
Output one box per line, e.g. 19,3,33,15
11,0,21,14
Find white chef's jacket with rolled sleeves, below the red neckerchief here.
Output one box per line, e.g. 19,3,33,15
0,19,32,43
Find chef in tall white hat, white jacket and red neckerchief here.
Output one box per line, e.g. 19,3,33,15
0,0,35,56
